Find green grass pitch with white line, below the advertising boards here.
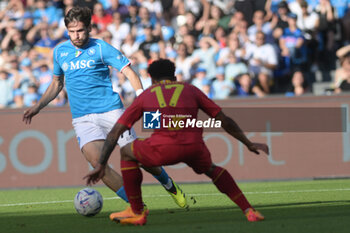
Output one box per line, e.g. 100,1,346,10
0,179,350,233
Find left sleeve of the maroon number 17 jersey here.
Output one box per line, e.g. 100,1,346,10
117,95,144,129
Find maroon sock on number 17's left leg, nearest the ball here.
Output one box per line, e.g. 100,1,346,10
120,160,143,214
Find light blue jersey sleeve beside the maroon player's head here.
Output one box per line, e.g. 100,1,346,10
100,41,130,71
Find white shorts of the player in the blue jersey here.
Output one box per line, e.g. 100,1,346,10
72,108,137,149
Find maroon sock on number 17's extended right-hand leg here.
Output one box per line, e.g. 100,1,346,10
210,167,252,212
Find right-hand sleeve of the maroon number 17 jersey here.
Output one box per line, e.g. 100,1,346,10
190,85,221,117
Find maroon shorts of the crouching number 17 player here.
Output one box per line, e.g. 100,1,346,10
131,138,212,174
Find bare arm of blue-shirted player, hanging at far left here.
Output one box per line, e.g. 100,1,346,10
23,75,64,124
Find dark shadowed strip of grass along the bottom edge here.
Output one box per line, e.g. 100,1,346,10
0,200,350,233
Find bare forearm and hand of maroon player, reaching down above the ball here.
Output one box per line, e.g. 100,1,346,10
83,123,128,185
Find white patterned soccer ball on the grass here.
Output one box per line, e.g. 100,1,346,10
74,188,103,216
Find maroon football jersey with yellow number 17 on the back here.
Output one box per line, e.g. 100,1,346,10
118,80,221,145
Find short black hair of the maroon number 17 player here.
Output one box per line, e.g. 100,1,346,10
147,59,176,81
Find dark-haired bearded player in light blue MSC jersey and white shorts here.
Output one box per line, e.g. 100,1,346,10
23,7,187,208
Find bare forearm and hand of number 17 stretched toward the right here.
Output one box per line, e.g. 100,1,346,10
215,111,269,155
